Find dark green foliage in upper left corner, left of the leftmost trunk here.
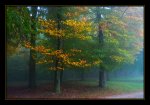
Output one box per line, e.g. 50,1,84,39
6,6,31,56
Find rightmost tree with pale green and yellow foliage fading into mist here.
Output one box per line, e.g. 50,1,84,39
91,7,142,87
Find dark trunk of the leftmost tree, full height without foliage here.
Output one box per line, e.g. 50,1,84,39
29,7,37,89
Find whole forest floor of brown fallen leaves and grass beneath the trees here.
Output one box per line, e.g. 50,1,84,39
6,81,143,100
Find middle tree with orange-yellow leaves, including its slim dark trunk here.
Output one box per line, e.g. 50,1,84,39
23,7,98,93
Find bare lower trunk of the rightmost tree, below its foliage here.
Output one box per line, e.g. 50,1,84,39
99,70,106,88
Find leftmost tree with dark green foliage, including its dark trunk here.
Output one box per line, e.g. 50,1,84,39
6,6,37,88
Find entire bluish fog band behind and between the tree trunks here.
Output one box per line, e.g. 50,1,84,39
7,48,144,85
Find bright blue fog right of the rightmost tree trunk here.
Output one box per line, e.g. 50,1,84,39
109,50,144,80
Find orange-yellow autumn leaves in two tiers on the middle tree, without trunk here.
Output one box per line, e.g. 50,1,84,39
24,8,100,70
